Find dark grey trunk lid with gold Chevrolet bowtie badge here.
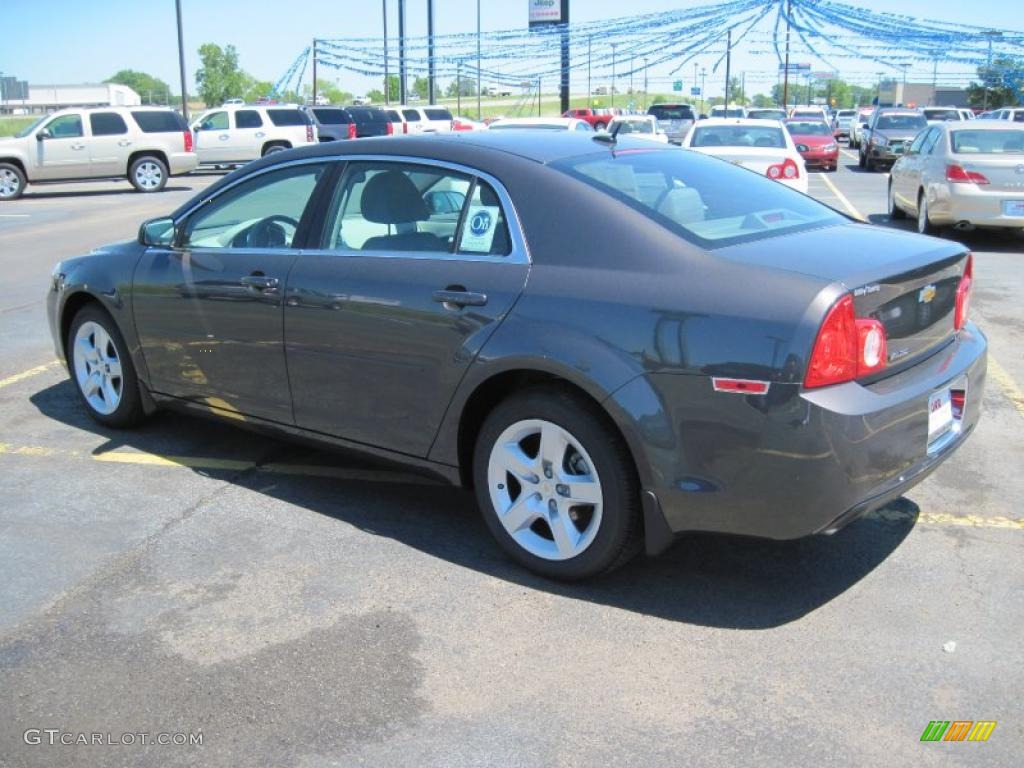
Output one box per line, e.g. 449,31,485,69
716,224,968,375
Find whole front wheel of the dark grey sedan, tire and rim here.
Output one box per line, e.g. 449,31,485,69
67,305,142,427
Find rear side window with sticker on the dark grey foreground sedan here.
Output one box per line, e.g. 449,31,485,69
326,162,510,256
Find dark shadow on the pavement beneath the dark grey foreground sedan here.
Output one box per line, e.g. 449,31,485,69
31,381,919,630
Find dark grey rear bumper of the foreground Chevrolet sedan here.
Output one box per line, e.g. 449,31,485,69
615,324,987,549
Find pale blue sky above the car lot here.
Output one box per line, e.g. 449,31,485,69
6,0,1024,101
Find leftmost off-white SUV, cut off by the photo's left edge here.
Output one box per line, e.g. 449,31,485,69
0,106,199,200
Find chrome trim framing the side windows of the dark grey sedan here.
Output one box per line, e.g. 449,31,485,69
174,154,534,264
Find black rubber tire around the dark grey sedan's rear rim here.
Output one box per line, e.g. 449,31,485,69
473,386,643,581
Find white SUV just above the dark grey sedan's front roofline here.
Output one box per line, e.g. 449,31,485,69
191,104,316,165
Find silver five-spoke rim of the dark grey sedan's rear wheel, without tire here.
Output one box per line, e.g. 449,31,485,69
487,419,604,560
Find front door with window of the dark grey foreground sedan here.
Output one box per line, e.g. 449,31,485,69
132,163,327,424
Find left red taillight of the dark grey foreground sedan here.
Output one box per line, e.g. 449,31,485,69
804,294,889,388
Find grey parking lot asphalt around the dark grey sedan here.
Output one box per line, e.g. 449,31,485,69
0,152,1024,768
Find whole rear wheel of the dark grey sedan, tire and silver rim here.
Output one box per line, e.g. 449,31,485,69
473,387,641,581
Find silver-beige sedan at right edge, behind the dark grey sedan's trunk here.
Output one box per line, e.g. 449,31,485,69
889,121,1024,234
